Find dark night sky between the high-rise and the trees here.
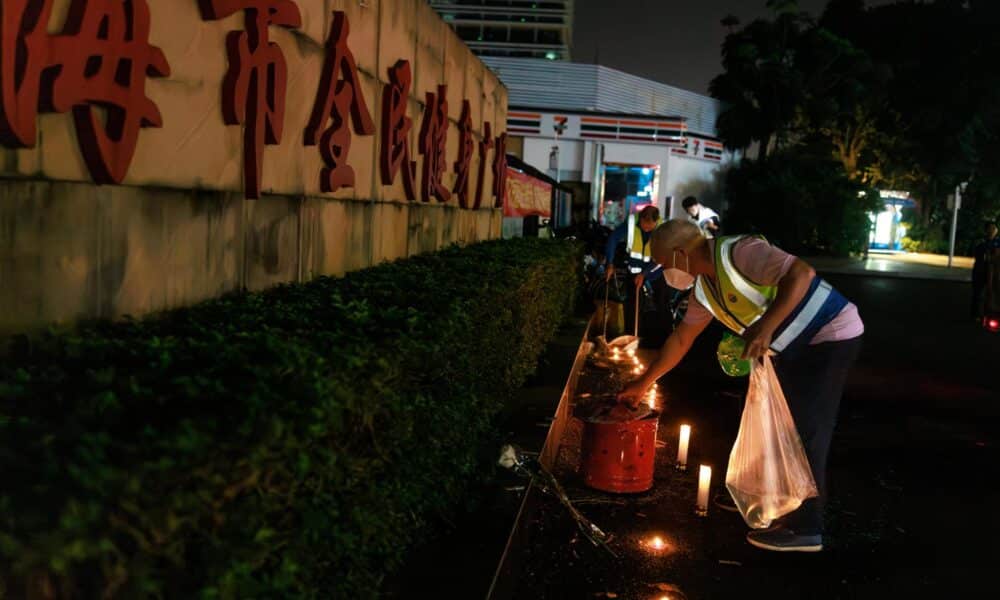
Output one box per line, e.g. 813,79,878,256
573,0,889,94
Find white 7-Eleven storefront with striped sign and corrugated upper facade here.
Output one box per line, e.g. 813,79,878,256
483,57,735,227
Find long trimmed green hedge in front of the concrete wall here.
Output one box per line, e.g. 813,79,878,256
0,240,579,600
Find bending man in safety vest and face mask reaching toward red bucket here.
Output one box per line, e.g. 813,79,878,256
619,219,864,552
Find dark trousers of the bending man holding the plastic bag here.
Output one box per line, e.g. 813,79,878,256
774,337,862,535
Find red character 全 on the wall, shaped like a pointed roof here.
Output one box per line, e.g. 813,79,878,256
305,11,375,192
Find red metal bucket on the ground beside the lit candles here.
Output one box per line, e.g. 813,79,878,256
580,411,660,494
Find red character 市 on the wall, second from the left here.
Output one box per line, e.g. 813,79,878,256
199,0,302,198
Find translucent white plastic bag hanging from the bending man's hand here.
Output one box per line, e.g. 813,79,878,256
726,356,819,529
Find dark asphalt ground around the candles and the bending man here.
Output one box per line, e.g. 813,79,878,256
504,276,1000,599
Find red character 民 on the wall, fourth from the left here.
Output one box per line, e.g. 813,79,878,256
379,60,417,200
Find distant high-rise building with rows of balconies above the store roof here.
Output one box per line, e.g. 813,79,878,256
430,0,573,60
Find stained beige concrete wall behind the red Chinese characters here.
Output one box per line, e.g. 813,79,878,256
0,0,507,334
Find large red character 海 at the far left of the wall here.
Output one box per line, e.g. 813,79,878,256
0,0,170,183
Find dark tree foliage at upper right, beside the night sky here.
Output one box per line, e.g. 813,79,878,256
710,0,1000,253
